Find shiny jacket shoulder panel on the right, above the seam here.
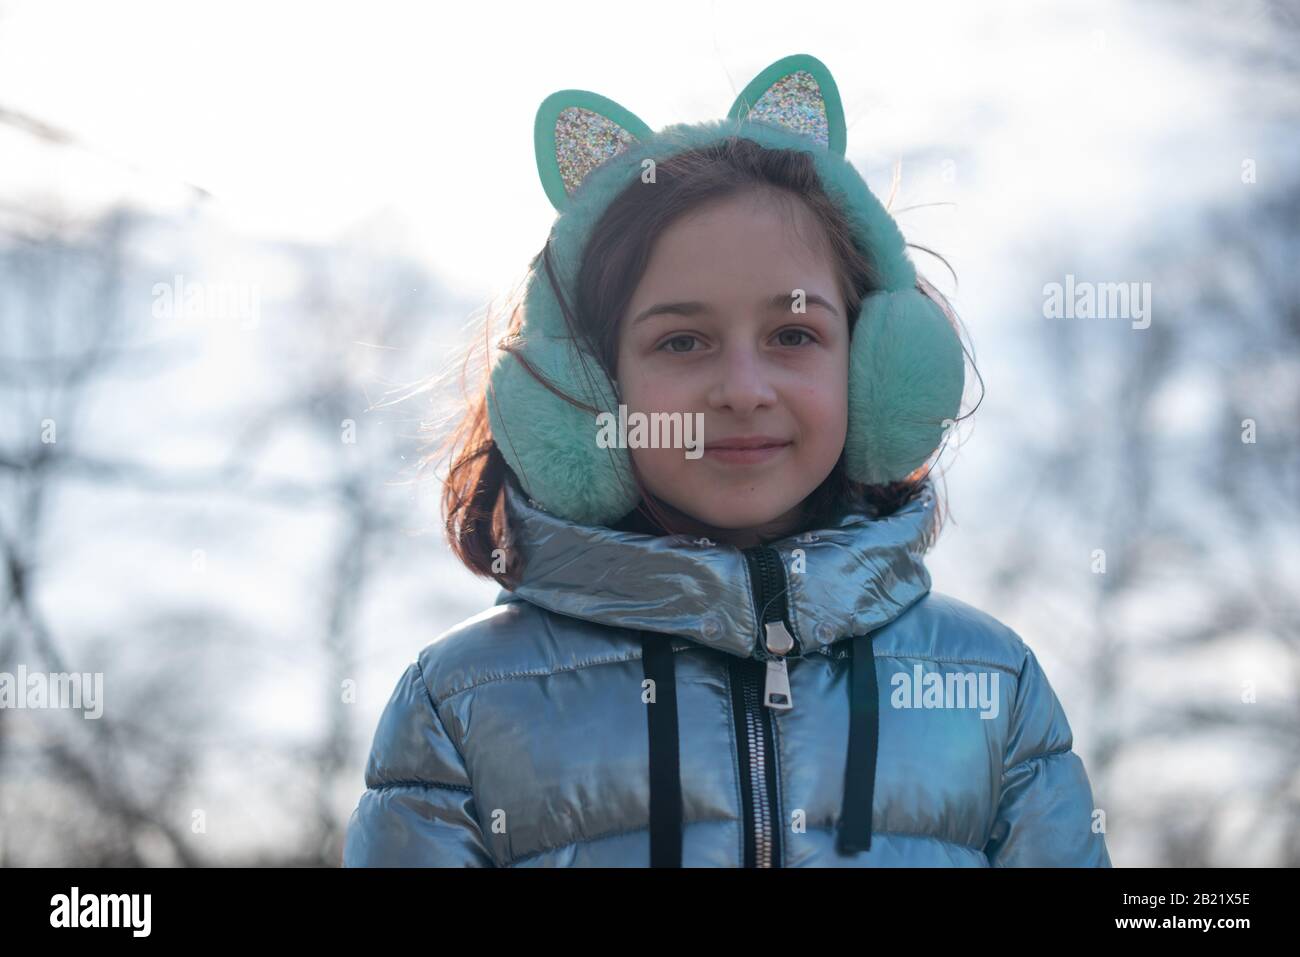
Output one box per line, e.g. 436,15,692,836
872,592,1030,675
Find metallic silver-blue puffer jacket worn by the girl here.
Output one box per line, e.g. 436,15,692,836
343,482,1110,867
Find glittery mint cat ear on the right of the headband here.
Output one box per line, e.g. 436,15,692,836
727,53,846,156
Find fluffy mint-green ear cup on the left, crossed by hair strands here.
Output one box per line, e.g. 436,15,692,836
488,338,640,525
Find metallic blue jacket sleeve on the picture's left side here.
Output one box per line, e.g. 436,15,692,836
343,661,493,867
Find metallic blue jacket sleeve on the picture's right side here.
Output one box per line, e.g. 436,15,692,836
984,646,1110,867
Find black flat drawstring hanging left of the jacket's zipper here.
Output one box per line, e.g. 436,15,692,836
641,632,681,867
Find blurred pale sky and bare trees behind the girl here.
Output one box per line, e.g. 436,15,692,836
0,0,1300,866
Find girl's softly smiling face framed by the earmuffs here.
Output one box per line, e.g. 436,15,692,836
616,189,849,547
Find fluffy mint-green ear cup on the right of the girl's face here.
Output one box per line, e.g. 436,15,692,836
844,289,966,485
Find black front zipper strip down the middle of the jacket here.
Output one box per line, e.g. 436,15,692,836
731,545,798,867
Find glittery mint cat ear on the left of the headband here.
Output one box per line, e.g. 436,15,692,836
533,90,653,212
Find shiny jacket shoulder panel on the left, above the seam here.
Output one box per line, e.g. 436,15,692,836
419,598,641,703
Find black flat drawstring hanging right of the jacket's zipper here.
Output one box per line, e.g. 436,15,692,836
837,635,880,854
